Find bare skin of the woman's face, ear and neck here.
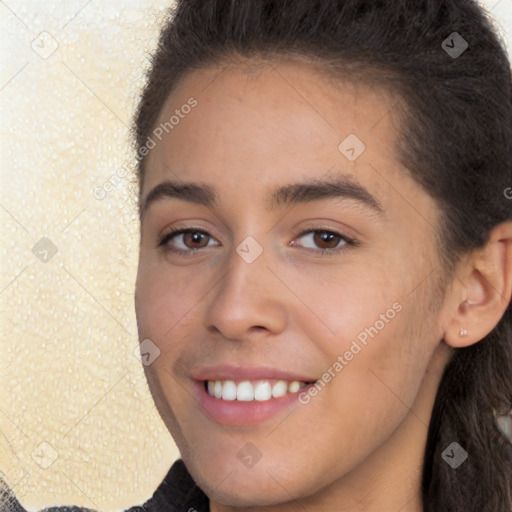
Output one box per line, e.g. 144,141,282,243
135,62,512,512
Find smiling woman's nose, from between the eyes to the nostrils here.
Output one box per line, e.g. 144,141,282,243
204,243,287,340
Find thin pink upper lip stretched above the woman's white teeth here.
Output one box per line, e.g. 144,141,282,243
190,364,316,382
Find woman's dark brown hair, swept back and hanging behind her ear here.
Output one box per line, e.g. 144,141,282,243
134,0,512,512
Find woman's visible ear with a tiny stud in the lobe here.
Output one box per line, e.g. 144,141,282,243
443,221,512,348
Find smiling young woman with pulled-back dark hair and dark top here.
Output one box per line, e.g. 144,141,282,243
6,0,512,512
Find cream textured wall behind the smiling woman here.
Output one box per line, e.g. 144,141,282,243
0,0,512,511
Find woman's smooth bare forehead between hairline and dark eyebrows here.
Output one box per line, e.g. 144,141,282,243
144,61,398,190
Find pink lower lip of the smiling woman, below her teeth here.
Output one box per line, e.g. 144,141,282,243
194,381,313,427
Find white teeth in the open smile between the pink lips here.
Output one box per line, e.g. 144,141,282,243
203,379,314,402
